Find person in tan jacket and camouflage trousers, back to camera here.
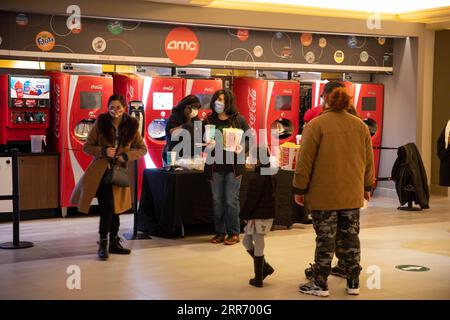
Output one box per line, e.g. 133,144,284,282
293,82,374,297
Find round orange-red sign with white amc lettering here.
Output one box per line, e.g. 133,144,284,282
164,27,199,66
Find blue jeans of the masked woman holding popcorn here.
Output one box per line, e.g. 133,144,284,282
211,172,242,235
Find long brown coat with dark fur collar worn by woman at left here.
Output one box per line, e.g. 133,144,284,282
71,113,147,214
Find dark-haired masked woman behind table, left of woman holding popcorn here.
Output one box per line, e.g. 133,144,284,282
162,94,201,164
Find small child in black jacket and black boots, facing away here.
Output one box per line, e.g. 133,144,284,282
240,147,276,288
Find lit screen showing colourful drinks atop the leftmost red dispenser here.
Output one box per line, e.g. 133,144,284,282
9,76,50,100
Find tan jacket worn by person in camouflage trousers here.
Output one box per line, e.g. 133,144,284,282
293,110,374,210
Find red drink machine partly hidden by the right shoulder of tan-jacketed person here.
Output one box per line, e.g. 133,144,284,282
353,83,384,181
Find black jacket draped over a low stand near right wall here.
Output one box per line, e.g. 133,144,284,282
392,143,430,209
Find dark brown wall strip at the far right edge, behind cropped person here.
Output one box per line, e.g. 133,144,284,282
431,30,450,191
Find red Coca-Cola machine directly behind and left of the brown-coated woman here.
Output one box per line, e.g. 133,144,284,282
48,72,113,215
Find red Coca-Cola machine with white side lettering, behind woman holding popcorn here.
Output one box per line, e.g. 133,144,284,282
233,78,300,146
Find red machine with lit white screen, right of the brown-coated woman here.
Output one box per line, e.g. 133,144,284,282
114,74,184,171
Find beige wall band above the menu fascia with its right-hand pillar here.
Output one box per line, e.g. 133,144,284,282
1,0,434,186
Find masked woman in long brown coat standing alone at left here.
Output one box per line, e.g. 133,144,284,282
71,95,147,260
